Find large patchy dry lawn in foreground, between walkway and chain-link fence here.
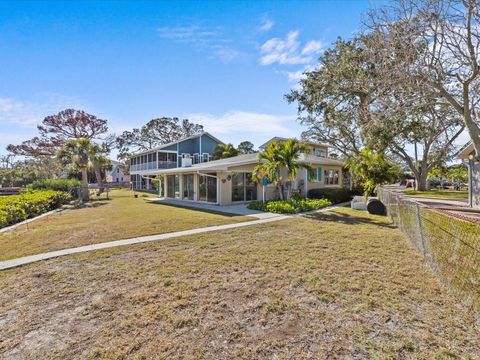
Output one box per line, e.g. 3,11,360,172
0,208,480,359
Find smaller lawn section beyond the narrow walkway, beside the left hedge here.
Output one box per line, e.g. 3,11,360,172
0,190,254,260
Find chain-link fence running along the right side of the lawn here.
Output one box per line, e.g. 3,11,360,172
378,188,480,310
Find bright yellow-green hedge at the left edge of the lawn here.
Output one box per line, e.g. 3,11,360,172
0,190,71,228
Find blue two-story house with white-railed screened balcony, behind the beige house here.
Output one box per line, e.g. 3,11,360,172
130,132,223,190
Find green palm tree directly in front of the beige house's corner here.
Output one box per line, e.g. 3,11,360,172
254,139,311,200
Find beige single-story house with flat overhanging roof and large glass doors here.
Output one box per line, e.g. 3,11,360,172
131,133,343,205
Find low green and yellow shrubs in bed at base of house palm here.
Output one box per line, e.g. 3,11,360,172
248,198,332,214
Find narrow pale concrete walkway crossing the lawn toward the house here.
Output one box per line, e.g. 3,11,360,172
0,203,345,270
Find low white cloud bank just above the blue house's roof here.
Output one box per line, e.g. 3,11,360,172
187,111,295,138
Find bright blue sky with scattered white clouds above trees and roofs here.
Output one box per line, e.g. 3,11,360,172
0,0,381,154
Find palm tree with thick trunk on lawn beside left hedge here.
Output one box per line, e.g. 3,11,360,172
57,138,92,202
